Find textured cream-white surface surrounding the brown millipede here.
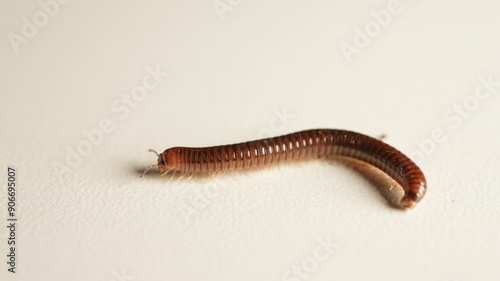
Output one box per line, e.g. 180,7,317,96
0,0,500,281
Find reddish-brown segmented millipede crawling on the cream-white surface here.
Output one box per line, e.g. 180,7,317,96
140,129,427,209
